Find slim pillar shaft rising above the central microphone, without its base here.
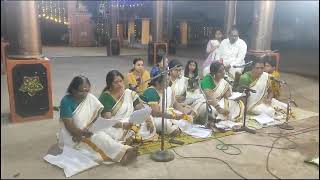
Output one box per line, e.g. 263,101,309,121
152,1,165,42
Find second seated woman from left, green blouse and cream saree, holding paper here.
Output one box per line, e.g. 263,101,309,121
99,70,157,143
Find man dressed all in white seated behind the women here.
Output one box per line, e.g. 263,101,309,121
216,28,247,80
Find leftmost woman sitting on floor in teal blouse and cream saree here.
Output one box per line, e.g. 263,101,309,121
58,76,137,164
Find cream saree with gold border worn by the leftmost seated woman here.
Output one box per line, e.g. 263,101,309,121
58,93,130,162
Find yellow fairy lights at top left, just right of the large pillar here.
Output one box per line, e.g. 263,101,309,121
37,0,69,25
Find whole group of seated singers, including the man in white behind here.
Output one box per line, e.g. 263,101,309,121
58,26,279,164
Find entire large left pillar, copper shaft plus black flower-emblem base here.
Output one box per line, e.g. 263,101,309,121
1,1,53,122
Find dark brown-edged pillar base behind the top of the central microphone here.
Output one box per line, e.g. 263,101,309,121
148,43,168,65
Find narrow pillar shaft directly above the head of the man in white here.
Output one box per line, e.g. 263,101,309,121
224,1,237,35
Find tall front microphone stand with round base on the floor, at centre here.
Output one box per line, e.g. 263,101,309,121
151,53,174,162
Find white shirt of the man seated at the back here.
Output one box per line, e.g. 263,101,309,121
215,38,247,66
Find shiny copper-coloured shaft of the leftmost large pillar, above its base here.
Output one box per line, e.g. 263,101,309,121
6,1,42,58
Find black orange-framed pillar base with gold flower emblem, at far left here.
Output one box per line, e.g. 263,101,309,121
7,59,53,122
